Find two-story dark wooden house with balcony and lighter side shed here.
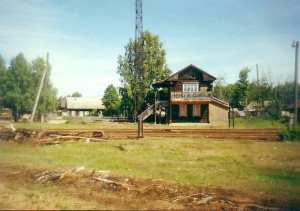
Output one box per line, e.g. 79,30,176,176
152,65,229,124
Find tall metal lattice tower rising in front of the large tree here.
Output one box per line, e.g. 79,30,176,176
134,0,144,121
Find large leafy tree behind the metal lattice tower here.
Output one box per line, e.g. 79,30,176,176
118,31,171,118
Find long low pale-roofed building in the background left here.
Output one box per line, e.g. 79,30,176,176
58,97,105,117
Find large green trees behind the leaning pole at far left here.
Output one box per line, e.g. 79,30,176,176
0,53,56,121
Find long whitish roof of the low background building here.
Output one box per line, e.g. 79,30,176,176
61,97,104,110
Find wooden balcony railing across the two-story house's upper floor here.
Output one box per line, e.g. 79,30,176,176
171,91,213,102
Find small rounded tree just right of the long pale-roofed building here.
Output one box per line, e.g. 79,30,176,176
102,84,121,116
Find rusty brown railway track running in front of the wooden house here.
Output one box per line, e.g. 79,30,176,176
44,128,278,141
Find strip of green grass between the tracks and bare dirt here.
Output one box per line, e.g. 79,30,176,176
0,137,300,201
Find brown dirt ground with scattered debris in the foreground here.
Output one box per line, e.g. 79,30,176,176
0,165,293,210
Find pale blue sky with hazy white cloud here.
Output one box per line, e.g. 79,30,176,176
0,0,300,97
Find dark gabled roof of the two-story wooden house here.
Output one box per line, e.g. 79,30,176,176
152,64,217,86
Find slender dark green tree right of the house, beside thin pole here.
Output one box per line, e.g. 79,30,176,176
231,67,250,109
